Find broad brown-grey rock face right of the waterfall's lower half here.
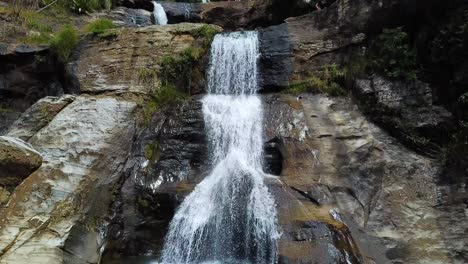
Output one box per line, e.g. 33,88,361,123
265,95,467,263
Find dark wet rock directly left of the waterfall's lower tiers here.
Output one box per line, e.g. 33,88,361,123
104,98,208,262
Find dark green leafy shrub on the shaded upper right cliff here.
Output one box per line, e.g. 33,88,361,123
371,27,418,80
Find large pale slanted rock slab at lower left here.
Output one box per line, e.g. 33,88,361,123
0,96,135,264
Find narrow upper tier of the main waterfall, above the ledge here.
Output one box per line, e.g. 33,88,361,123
208,31,260,95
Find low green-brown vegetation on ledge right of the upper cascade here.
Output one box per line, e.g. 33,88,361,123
286,64,345,96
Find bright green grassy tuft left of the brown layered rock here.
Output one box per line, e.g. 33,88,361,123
51,26,79,61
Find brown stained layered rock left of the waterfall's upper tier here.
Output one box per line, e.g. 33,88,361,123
69,23,217,94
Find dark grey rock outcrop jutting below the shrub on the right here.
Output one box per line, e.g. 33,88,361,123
355,76,454,155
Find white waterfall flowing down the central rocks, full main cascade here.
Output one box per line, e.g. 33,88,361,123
161,32,279,264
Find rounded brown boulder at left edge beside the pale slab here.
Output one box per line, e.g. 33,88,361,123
0,137,42,205
